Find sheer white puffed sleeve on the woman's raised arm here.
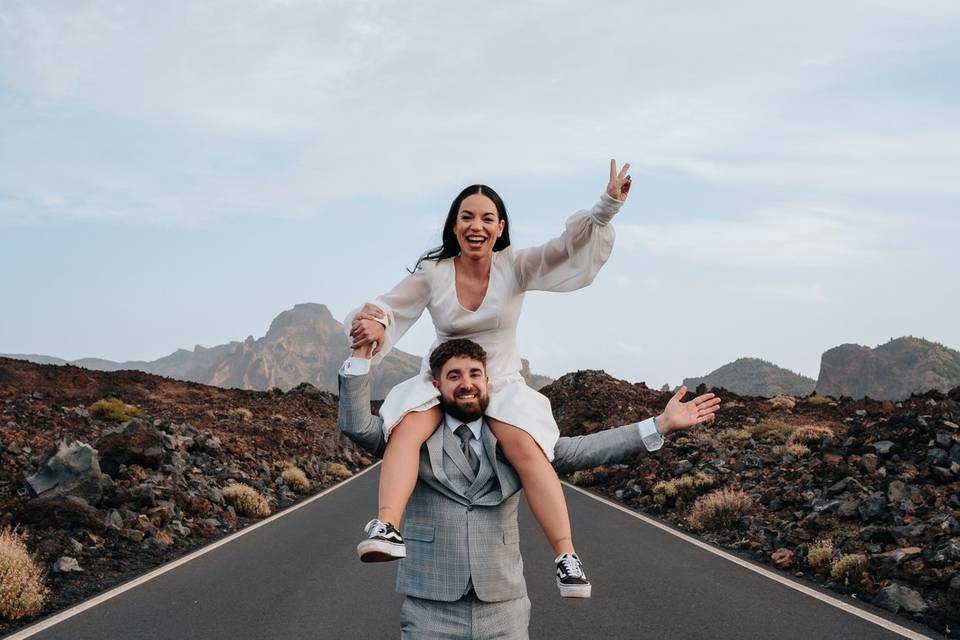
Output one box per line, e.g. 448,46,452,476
514,193,623,291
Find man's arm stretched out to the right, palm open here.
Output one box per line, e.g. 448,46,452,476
553,387,720,473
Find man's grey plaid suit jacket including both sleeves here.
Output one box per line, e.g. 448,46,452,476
338,375,647,602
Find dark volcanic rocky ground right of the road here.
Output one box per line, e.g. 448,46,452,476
541,371,960,637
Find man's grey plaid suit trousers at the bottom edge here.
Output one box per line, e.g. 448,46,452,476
400,589,530,640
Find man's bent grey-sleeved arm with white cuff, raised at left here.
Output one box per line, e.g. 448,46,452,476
337,357,387,457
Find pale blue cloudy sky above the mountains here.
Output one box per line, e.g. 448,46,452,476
0,0,960,386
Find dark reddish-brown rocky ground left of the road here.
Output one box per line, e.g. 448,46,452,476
0,358,370,636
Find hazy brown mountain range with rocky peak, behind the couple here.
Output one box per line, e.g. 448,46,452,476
0,303,552,399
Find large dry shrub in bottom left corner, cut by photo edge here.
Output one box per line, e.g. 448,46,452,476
0,526,50,620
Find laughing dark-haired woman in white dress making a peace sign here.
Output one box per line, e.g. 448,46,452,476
345,160,631,597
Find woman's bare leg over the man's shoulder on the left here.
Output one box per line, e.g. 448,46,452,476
377,407,443,529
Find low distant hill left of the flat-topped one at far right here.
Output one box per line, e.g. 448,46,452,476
683,358,817,397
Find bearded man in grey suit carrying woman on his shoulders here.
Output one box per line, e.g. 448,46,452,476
338,340,720,639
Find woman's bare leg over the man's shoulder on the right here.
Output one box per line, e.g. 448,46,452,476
487,416,575,556
